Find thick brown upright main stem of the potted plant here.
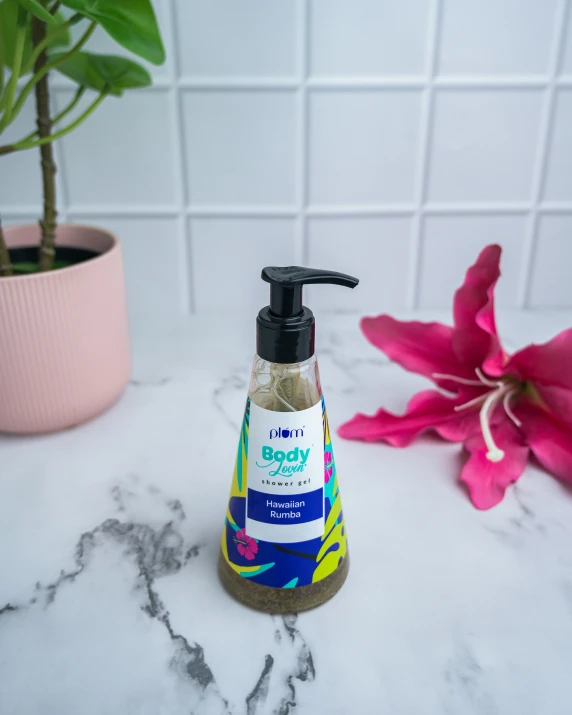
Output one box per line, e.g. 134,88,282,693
32,17,58,271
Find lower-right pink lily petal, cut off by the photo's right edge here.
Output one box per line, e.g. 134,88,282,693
515,400,572,482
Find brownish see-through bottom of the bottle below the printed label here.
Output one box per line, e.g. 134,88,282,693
218,554,350,614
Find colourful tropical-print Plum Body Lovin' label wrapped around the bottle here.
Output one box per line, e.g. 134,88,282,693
221,398,347,588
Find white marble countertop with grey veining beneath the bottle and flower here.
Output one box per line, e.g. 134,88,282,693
0,313,572,715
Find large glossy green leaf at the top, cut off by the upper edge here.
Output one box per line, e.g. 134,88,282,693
63,0,165,65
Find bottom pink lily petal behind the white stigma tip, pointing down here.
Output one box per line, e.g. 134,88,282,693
461,420,529,509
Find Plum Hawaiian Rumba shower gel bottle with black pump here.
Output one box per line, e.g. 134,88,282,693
219,266,358,613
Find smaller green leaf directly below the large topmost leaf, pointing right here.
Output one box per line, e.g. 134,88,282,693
50,52,151,97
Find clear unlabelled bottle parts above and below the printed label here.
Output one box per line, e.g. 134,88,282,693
219,355,349,613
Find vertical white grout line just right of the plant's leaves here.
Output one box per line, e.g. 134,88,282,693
166,0,196,315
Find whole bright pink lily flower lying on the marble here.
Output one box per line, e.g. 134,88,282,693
339,245,572,509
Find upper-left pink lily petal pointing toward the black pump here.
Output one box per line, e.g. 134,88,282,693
360,315,474,392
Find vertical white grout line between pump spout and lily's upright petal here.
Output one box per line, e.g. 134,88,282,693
407,0,442,310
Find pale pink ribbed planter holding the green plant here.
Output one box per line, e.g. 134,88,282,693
0,225,131,434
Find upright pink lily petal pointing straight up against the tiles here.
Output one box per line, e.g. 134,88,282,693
453,244,505,375
